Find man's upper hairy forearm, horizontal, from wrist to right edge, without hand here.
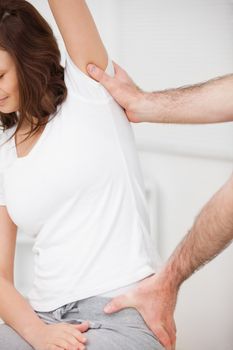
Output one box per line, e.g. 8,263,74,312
139,74,233,124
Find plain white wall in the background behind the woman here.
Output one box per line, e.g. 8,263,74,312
3,0,233,350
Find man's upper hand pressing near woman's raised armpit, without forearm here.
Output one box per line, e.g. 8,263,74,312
87,62,145,123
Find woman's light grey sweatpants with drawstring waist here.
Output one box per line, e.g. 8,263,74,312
0,296,164,350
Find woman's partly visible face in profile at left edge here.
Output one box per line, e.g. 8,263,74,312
0,49,19,113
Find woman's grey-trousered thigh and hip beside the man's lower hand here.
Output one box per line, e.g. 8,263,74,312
74,296,164,350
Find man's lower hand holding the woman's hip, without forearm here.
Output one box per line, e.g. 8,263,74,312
104,274,177,350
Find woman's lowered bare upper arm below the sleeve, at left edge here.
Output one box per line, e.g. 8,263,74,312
0,205,17,283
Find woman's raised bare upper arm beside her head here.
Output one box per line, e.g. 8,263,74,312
48,0,108,75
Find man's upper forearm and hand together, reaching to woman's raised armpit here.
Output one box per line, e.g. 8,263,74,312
87,62,233,124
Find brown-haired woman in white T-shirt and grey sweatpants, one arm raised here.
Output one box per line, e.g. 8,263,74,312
0,0,161,350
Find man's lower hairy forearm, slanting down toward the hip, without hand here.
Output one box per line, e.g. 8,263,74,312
161,176,233,290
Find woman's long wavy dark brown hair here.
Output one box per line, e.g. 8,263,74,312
0,0,67,146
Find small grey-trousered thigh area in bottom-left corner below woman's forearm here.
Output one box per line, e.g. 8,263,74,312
0,324,33,350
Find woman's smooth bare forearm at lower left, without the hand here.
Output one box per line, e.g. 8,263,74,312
0,277,44,344
